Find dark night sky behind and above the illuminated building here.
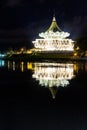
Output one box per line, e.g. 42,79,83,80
0,0,87,50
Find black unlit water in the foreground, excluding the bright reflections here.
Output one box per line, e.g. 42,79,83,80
0,60,87,130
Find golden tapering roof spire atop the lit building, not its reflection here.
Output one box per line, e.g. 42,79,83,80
47,16,62,32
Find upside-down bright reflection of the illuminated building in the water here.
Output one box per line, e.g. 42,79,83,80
32,63,75,98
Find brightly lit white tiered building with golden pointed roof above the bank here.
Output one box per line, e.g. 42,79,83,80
33,16,74,52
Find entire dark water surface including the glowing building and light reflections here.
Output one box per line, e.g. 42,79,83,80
0,60,87,130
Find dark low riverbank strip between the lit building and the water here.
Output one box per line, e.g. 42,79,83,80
2,53,87,61
